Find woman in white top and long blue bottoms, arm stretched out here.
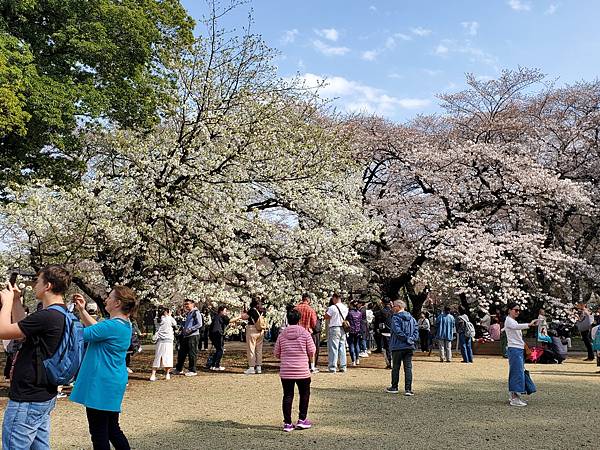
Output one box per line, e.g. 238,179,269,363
504,302,539,406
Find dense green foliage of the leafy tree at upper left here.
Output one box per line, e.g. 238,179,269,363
0,0,194,198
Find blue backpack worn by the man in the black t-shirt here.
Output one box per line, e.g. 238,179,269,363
36,305,83,386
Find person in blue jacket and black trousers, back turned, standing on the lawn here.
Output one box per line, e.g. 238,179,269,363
386,300,419,397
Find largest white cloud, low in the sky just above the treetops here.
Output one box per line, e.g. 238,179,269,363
302,73,431,116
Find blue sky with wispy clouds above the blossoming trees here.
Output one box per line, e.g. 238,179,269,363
182,0,600,121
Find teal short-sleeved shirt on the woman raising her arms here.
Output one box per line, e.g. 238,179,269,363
70,319,131,412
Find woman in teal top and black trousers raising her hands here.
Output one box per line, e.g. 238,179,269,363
71,286,138,450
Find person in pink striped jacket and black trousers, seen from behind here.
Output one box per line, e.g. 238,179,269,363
274,309,315,432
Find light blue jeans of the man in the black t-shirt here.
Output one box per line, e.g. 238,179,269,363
2,397,56,450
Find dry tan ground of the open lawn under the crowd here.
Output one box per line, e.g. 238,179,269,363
0,343,600,449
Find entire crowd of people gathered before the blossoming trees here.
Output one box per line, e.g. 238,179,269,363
0,266,600,449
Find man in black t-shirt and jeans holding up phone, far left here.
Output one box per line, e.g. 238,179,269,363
0,265,77,450
